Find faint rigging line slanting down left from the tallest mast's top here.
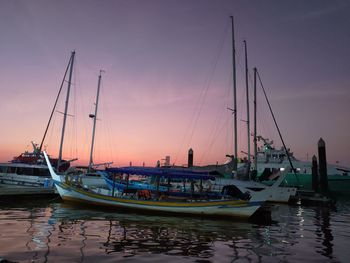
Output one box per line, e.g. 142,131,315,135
174,20,230,166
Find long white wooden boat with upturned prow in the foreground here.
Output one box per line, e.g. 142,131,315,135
44,152,276,218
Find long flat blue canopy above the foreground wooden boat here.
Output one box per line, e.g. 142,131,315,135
106,166,215,180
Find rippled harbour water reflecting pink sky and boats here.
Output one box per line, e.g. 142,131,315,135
0,200,350,262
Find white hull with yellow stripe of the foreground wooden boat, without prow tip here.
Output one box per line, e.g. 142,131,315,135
55,182,263,218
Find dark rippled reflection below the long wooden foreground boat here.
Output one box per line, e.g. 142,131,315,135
51,204,263,259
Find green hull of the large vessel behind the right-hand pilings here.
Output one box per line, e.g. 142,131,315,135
263,173,350,195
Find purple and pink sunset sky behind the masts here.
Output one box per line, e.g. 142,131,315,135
0,0,350,166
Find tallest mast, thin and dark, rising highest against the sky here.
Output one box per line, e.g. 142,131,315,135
231,16,238,171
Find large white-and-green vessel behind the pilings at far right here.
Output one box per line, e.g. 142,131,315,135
250,136,350,195
